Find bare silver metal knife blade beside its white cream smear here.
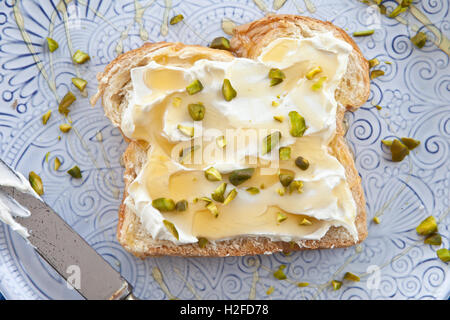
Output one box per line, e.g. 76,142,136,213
0,159,136,300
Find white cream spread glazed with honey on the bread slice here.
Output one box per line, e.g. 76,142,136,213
121,33,357,244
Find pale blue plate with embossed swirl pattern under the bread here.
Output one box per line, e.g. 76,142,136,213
0,0,450,299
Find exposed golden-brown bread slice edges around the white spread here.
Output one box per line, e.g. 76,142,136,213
91,15,369,258
